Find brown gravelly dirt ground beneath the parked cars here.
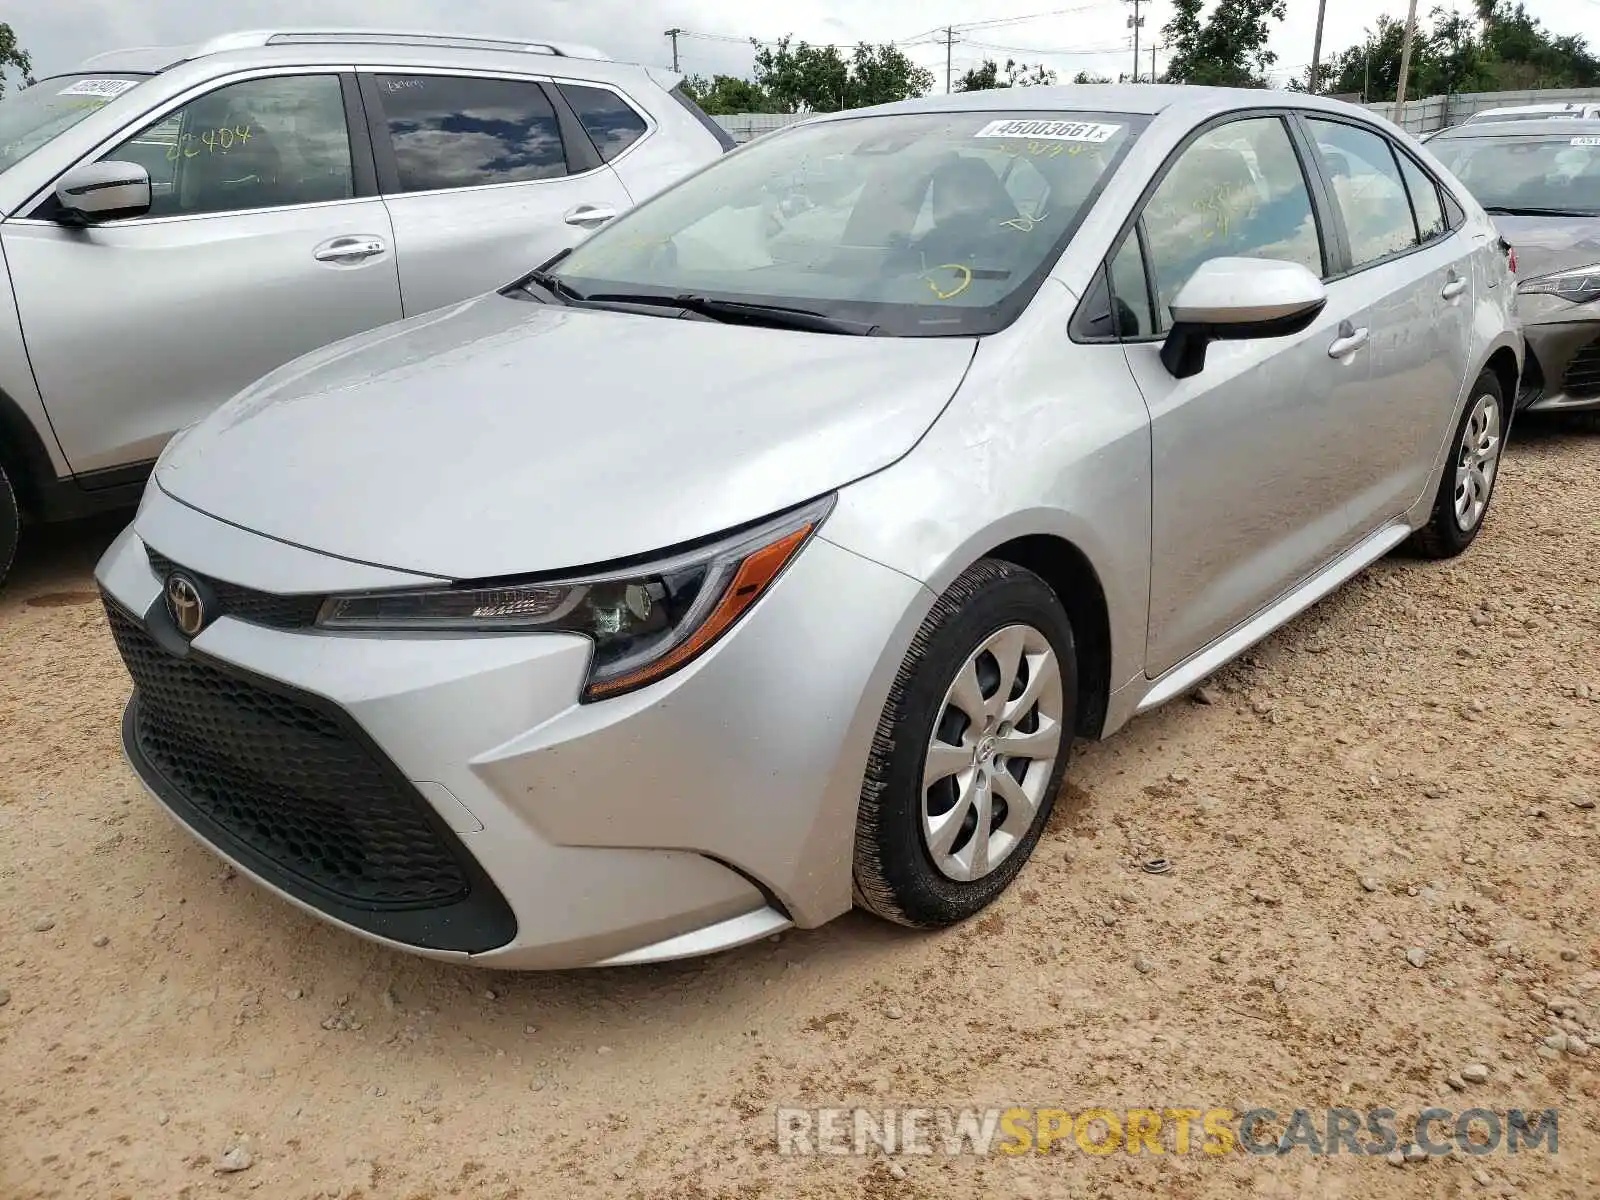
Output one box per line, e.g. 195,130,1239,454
0,422,1600,1200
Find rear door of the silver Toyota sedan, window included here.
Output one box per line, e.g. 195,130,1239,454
1306,117,1475,531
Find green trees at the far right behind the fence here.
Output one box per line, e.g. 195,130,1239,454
1298,0,1600,101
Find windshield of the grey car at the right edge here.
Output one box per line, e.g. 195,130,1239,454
1427,134,1600,216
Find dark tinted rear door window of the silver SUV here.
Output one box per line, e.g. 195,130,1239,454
374,75,566,192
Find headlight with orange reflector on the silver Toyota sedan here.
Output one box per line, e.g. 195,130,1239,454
317,496,834,701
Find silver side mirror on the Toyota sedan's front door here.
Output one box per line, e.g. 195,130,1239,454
1162,258,1328,379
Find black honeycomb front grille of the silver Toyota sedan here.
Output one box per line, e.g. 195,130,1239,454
106,603,515,950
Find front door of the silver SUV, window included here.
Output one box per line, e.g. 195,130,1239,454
0,74,402,475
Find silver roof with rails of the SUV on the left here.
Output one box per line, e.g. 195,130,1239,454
74,27,611,74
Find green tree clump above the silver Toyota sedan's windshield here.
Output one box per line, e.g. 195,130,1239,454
754,37,933,112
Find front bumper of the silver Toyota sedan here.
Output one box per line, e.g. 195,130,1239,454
98,490,933,968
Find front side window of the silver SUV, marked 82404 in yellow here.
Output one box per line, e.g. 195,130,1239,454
101,75,355,216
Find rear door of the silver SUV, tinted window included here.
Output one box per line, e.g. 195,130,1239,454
362,69,630,315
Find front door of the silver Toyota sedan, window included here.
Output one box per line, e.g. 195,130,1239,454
1128,117,1370,677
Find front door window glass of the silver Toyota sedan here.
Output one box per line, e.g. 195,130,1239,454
1144,117,1325,325
